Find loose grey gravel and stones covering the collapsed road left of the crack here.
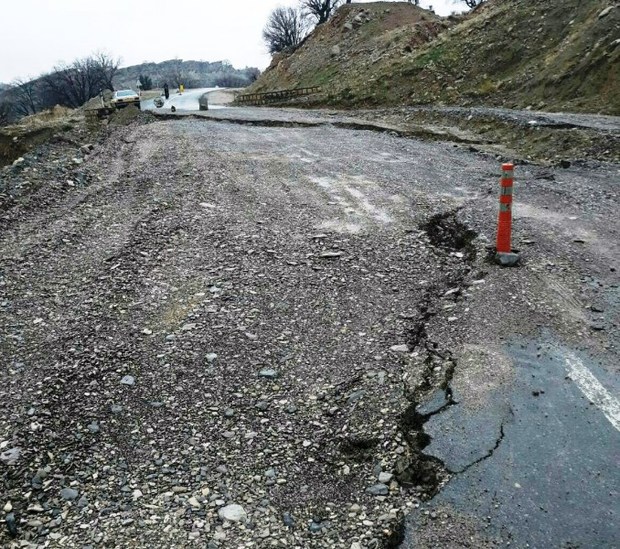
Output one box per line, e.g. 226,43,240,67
0,105,613,548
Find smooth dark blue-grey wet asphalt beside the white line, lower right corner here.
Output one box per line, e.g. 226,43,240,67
402,343,620,548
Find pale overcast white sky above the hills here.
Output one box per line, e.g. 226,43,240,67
0,0,458,83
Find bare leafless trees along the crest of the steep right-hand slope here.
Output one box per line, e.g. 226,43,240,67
263,0,484,54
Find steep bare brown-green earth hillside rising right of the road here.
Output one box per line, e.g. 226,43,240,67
251,0,620,114
